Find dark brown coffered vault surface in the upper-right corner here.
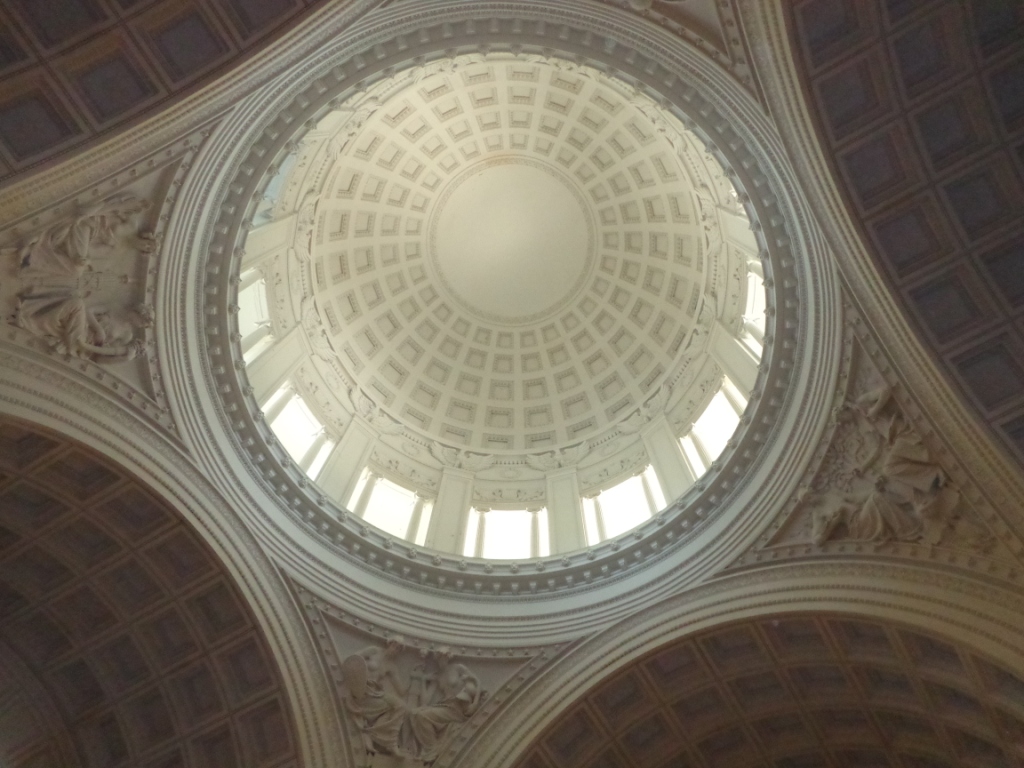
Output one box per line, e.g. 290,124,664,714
790,0,1024,461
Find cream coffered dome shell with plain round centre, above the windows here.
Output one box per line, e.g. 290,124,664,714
312,58,708,452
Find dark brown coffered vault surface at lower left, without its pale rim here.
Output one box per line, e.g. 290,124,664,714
0,422,296,768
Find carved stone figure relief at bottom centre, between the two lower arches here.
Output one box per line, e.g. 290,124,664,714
342,638,485,766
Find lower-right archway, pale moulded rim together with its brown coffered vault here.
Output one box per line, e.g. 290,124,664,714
462,559,1024,768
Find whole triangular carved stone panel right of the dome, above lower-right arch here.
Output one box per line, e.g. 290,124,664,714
741,324,1014,573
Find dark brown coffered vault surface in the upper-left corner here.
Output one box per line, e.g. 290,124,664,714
0,0,331,182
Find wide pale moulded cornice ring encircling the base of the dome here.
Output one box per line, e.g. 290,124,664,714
157,0,841,643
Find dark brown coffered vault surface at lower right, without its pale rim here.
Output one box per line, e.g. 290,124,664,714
518,615,1024,768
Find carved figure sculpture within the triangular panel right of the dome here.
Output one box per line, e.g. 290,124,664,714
801,387,992,549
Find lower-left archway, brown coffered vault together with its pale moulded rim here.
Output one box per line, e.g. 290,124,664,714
0,393,338,766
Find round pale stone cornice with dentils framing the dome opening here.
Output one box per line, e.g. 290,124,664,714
151,2,839,638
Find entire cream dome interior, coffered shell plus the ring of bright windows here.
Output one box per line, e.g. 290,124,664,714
240,53,765,556
